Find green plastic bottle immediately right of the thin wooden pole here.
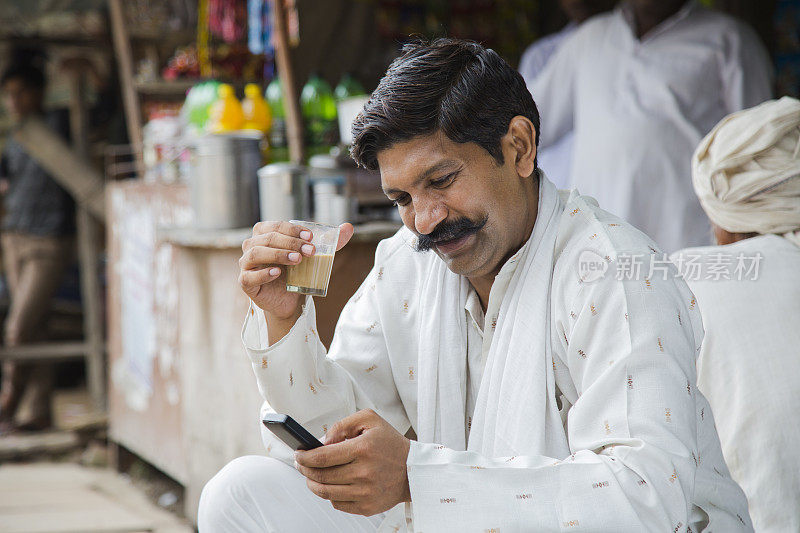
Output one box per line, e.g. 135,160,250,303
300,74,339,156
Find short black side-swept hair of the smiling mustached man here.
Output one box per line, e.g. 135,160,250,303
351,39,539,170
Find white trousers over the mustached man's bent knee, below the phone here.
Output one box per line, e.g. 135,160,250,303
202,455,384,533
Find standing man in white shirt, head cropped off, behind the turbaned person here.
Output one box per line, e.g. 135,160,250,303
528,0,772,251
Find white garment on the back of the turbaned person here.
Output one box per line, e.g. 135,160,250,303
673,235,800,532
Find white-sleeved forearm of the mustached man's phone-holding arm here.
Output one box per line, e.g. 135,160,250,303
407,442,700,531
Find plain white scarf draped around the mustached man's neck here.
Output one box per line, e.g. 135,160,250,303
418,176,569,457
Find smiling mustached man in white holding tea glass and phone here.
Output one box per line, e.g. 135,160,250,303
199,40,751,532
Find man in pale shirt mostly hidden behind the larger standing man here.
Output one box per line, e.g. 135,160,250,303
518,0,617,189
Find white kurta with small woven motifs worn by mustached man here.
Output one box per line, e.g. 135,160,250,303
243,180,751,532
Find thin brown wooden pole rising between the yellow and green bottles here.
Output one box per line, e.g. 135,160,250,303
270,0,305,165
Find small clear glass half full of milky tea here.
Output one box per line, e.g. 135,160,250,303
286,220,339,297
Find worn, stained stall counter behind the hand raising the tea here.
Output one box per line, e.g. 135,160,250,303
108,182,399,519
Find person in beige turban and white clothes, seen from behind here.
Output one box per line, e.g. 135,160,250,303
672,97,800,531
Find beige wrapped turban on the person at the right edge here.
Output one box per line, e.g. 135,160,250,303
692,96,800,246
